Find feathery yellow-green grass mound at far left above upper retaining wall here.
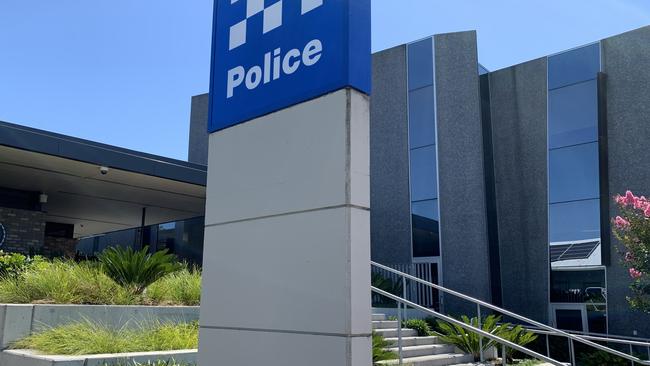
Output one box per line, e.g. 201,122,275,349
0,260,139,305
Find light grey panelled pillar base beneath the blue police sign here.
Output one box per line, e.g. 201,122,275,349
199,89,372,366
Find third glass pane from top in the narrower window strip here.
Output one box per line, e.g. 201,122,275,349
411,145,438,201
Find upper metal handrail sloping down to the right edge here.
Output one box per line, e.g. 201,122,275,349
370,261,650,366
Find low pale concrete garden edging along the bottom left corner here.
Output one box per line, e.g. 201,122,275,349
0,349,197,366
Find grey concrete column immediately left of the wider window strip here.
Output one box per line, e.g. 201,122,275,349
490,58,551,323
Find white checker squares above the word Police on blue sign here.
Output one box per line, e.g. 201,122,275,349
228,0,324,51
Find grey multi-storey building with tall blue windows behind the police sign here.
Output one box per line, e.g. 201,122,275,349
190,27,650,337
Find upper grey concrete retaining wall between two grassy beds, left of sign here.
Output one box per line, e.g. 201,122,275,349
0,304,199,350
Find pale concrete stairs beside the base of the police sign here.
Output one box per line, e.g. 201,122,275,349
372,314,474,366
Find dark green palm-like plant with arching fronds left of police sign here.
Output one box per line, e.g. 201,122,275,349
98,246,183,295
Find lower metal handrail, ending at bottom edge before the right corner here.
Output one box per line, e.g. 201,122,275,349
370,286,566,366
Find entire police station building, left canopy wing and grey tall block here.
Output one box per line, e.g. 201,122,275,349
0,27,650,338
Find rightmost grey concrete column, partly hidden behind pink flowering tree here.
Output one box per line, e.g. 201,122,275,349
602,27,650,337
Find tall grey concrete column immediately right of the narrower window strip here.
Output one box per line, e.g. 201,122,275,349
434,32,491,316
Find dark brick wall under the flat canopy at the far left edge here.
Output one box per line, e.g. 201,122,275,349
0,207,45,254
